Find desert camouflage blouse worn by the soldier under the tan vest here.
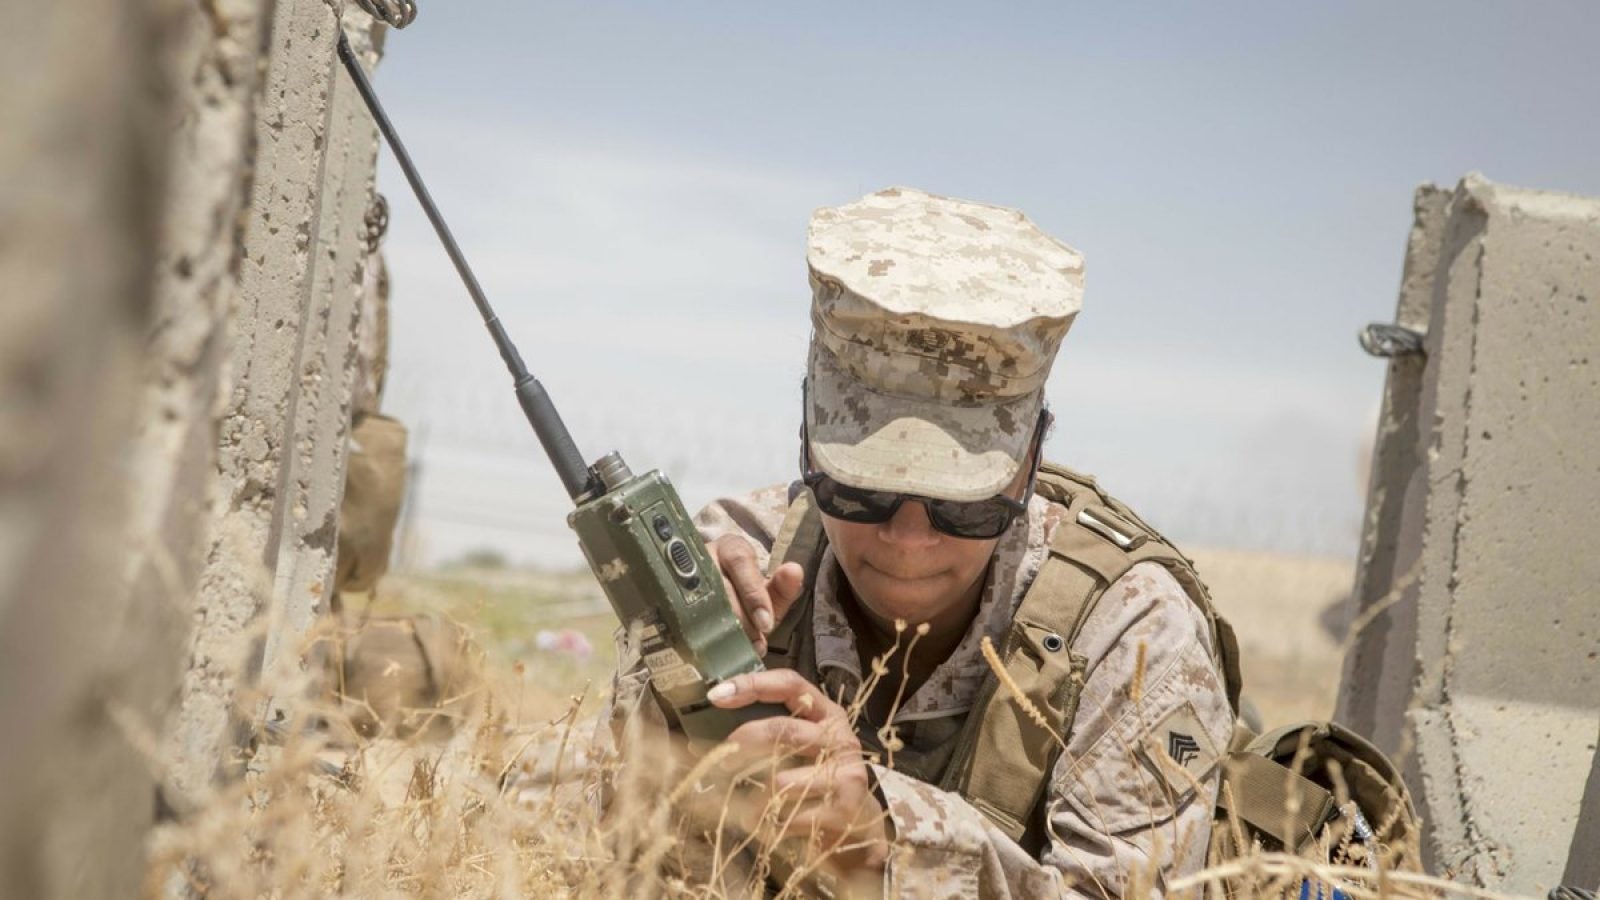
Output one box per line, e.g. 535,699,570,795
613,485,1232,898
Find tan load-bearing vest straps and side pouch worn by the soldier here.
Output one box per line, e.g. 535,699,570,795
768,463,1416,870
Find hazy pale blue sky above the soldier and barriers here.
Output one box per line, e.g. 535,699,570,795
366,0,1600,565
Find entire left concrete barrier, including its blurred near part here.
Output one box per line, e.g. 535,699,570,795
0,0,381,897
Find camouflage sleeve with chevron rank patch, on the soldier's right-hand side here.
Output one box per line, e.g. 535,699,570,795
874,564,1232,898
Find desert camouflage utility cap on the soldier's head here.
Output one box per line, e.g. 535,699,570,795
805,187,1083,500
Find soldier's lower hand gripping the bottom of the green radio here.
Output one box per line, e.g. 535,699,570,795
707,669,890,871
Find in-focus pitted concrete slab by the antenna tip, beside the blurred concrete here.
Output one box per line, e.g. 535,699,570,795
165,0,376,801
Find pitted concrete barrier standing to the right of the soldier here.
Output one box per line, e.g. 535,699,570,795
1341,176,1600,892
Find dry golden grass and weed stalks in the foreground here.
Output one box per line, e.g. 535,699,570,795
144,582,1494,900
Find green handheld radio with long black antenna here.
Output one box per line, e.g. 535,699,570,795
338,30,787,746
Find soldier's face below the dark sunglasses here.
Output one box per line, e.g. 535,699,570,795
822,466,1029,633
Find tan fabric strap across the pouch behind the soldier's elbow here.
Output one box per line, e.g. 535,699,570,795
1218,751,1336,854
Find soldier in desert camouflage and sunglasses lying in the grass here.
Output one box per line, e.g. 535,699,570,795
611,189,1232,897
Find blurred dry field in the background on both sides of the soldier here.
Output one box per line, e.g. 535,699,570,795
373,549,1354,724
